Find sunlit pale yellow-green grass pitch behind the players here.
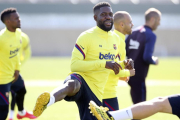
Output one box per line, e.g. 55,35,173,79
8,57,180,120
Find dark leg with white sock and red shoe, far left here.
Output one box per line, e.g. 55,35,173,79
11,75,36,119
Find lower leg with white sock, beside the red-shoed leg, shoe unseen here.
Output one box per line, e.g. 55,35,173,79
9,90,16,120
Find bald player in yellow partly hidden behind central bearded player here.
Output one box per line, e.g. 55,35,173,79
103,11,135,111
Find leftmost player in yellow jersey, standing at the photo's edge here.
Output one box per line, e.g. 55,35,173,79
0,9,21,120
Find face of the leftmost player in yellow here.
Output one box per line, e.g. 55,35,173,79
9,12,21,29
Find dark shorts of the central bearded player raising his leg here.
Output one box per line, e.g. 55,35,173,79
64,74,102,120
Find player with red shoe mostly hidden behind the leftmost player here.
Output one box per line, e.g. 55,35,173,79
9,32,32,120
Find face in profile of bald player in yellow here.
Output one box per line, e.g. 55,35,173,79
124,15,134,35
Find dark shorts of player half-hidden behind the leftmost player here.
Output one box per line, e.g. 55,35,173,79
11,75,25,93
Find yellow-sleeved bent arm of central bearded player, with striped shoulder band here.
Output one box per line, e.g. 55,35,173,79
71,35,106,72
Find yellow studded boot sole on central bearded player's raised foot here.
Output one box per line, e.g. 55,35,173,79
33,92,50,117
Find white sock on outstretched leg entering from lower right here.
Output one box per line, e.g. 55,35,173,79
109,108,133,120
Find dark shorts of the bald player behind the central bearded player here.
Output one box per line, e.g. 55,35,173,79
103,97,119,111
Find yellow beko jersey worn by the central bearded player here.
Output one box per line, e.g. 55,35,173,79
71,26,119,101
